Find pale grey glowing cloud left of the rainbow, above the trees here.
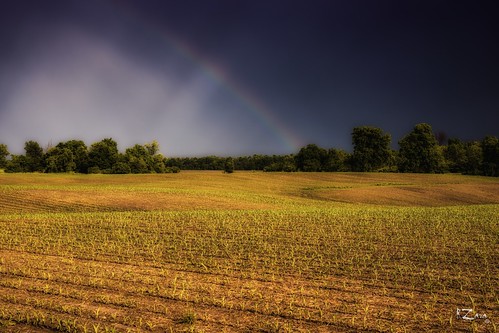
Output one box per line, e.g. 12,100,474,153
0,28,290,155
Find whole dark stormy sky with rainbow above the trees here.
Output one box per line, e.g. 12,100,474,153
0,0,499,156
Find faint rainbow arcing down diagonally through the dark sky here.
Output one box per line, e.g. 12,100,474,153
114,2,303,153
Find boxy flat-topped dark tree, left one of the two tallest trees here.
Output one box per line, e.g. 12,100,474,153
352,126,392,172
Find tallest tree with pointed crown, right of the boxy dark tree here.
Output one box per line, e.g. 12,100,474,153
398,123,444,173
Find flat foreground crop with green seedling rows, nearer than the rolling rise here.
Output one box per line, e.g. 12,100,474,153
0,206,499,331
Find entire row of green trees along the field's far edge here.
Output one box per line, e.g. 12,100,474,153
0,123,499,177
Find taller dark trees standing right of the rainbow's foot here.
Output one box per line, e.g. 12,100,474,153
296,123,499,177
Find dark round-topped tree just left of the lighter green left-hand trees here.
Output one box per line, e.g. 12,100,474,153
88,138,118,173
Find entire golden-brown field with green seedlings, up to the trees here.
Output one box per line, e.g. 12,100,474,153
0,172,499,333
